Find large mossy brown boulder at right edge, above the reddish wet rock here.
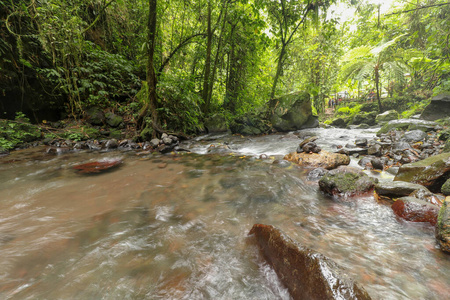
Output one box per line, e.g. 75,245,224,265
394,153,450,192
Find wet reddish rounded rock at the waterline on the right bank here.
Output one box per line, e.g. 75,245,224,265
391,197,439,226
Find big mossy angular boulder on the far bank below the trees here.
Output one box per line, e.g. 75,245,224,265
270,92,319,131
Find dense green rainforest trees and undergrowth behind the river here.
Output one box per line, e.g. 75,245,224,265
0,0,450,148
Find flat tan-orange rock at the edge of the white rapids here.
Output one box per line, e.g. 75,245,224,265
284,150,350,170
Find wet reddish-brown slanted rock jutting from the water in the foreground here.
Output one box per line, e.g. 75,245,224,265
249,224,371,300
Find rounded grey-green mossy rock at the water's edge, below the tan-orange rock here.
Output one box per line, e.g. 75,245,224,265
319,166,376,196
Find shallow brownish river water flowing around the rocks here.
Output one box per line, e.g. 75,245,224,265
0,129,450,299
